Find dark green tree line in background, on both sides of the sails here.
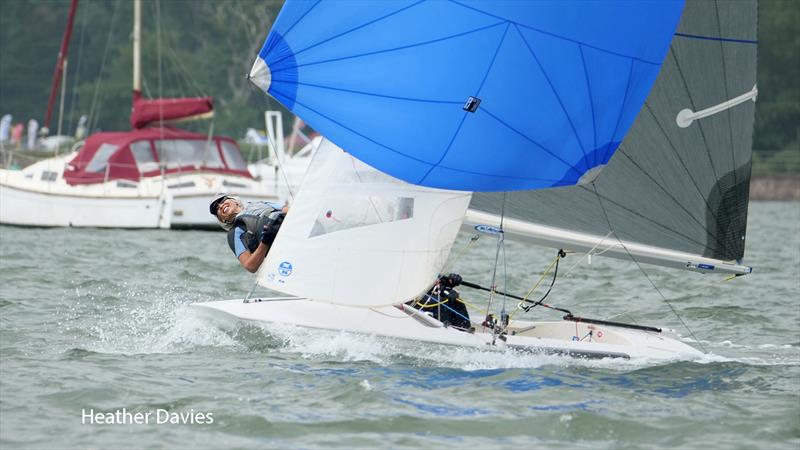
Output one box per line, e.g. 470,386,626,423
0,0,800,163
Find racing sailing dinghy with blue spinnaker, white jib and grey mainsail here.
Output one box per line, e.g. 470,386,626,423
195,0,757,359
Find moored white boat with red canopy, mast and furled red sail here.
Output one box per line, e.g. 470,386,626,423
0,0,310,228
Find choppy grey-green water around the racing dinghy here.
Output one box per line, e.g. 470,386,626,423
0,203,800,449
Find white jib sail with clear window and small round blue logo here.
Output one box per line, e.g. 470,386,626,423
258,140,470,306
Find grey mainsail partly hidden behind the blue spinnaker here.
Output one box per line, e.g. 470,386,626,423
470,0,757,260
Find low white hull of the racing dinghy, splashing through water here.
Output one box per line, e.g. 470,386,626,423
192,298,702,360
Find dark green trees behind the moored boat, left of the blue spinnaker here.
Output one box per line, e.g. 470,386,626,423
0,0,282,136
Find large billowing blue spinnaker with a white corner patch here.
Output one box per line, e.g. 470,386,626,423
251,0,683,191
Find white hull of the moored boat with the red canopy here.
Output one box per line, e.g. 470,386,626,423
0,154,307,229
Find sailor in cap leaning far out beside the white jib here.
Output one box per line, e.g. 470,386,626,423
209,194,288,273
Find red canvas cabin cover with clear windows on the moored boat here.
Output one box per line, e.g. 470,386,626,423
64,127,252,185
